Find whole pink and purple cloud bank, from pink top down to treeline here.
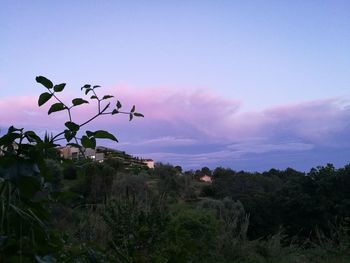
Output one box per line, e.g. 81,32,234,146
0,86,350,170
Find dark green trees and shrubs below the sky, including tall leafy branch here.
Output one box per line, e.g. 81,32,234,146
0,78,350,263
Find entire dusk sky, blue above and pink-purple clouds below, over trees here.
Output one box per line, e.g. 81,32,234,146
0,0,350,171
